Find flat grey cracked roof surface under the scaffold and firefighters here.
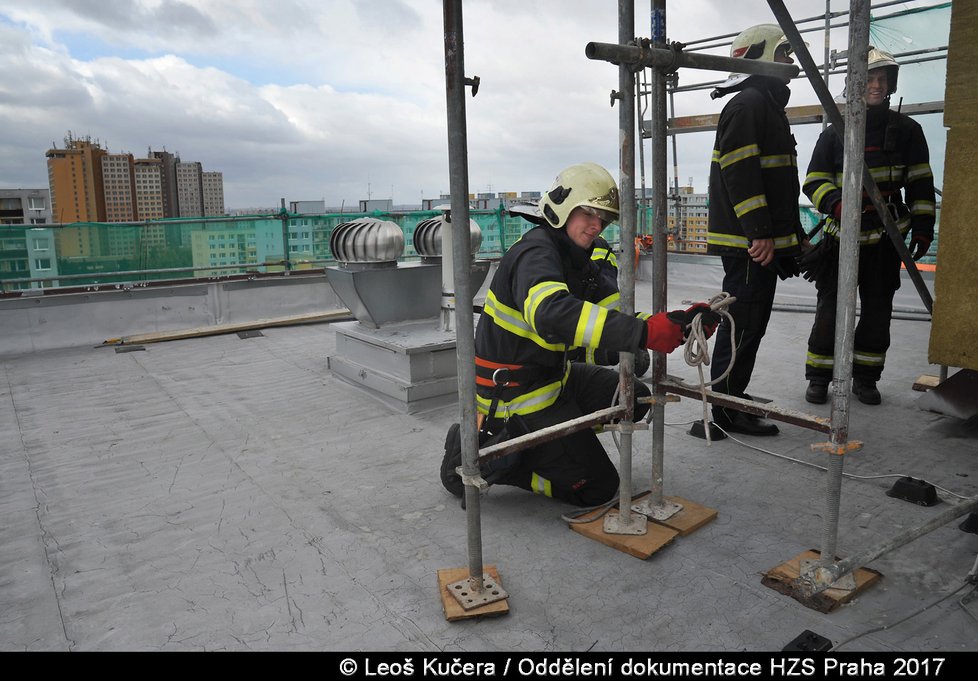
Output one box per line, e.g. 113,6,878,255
0,265,978,652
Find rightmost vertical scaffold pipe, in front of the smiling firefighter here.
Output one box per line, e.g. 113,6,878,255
819,0,869,565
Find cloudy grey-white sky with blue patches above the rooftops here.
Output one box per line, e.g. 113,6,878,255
0,0,949,209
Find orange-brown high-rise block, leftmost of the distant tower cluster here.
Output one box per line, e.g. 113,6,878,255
45,133,106,224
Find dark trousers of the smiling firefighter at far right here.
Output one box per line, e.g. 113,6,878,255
805,234,900,383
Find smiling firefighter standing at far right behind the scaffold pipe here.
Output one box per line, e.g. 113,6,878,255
802,46,935,404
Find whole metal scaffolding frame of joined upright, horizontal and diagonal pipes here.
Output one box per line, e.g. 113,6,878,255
443,0,978,607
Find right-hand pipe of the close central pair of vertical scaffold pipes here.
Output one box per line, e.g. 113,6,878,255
649,0,669,507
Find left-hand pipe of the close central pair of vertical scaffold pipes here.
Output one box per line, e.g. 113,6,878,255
618,0,637,526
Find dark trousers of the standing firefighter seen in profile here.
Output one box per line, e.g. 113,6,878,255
710,255,778,422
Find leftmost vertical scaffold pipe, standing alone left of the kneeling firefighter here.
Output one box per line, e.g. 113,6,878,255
443,0,483,591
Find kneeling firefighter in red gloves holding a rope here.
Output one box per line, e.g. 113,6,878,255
441,163,719,506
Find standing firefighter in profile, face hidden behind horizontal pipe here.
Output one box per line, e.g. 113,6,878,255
690,24,804,439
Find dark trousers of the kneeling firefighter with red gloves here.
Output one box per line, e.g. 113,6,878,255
496,362,652,506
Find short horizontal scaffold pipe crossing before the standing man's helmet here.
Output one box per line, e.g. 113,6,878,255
584,43,800,78
